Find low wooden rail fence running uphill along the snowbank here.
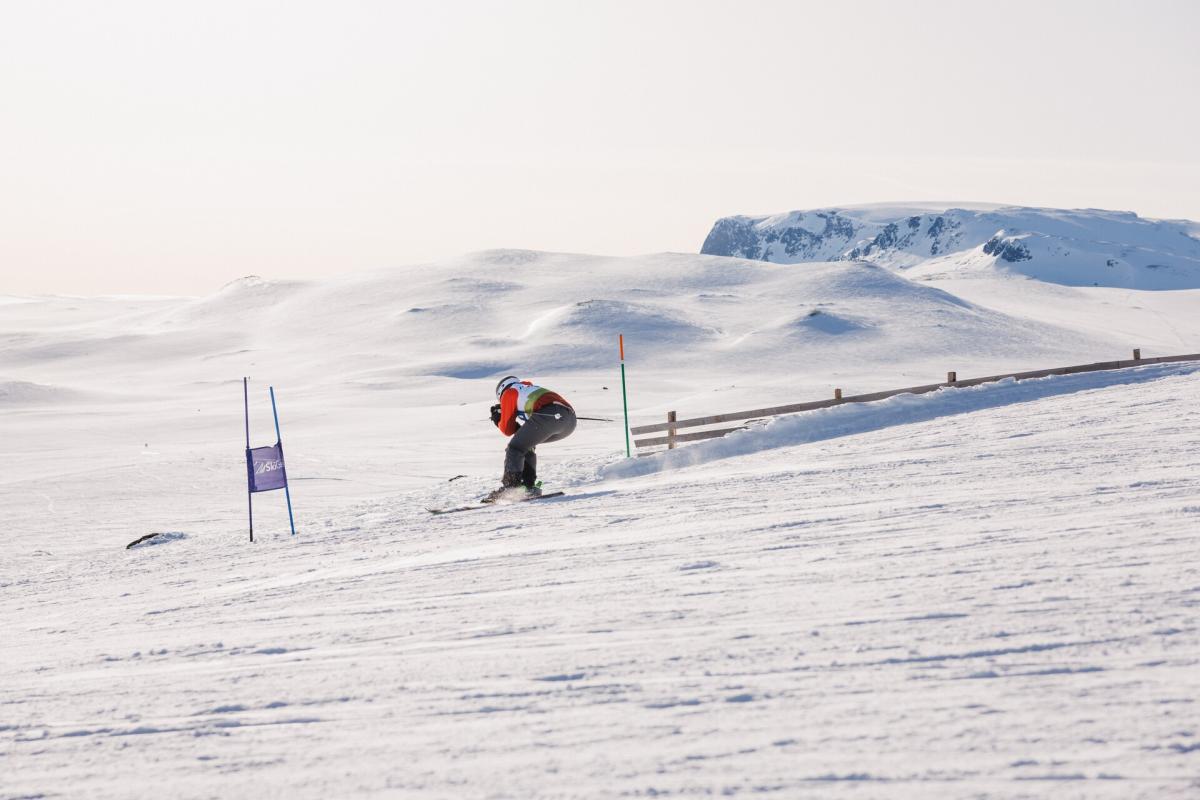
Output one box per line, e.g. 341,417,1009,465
630,350,1200,456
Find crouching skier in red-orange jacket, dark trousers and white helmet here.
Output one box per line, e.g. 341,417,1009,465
484,375,576,503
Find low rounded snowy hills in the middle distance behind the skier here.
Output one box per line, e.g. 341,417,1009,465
0,251,1104,393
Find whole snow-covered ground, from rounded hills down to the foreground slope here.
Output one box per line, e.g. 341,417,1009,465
0,251,1200,799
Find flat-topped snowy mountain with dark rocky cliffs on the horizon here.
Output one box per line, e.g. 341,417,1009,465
701,204,1200,289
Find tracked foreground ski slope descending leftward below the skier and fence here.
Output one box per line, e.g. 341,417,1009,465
0,373,1200,800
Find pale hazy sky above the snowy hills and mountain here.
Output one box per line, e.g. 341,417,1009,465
0,0,1200,295
